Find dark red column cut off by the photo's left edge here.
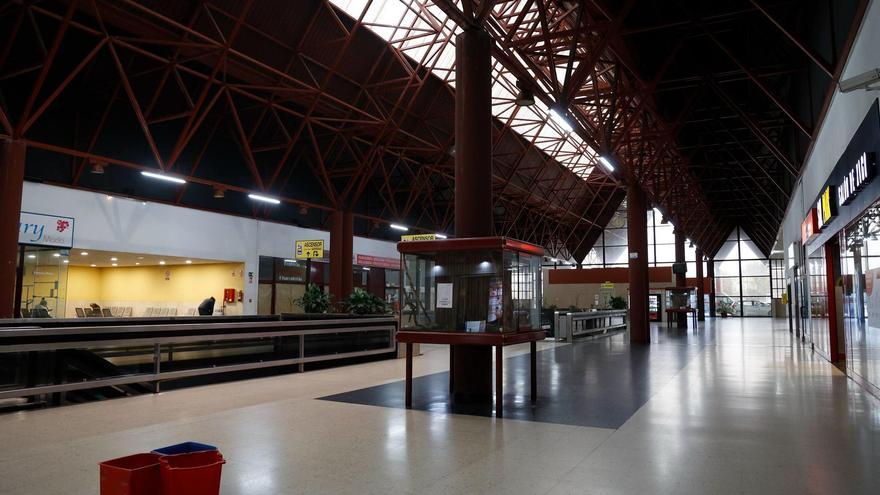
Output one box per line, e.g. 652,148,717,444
0,140,27,318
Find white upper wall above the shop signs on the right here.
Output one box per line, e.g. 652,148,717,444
782,0,880,266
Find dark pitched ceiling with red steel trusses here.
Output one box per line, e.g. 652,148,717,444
0,0,867,260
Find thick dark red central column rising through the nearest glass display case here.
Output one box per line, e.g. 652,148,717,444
450,29,494,403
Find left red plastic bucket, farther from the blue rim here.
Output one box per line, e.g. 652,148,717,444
100,454,162,495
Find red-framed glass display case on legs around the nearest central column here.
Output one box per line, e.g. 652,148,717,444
397,237,546,416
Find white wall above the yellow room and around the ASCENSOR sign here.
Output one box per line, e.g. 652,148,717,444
21,182,399,314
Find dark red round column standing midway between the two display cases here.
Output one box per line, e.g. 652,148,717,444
626,180,651,344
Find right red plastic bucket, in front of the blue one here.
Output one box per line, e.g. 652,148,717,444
159,450,226,495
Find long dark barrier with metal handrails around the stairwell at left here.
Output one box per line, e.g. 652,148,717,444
0,317,397,399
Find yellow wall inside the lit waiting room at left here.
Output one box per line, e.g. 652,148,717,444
67,263,244,316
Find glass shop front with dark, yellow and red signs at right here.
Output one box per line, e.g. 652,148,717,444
796,101,880,391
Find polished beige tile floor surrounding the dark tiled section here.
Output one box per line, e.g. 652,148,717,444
0,319,880,495
